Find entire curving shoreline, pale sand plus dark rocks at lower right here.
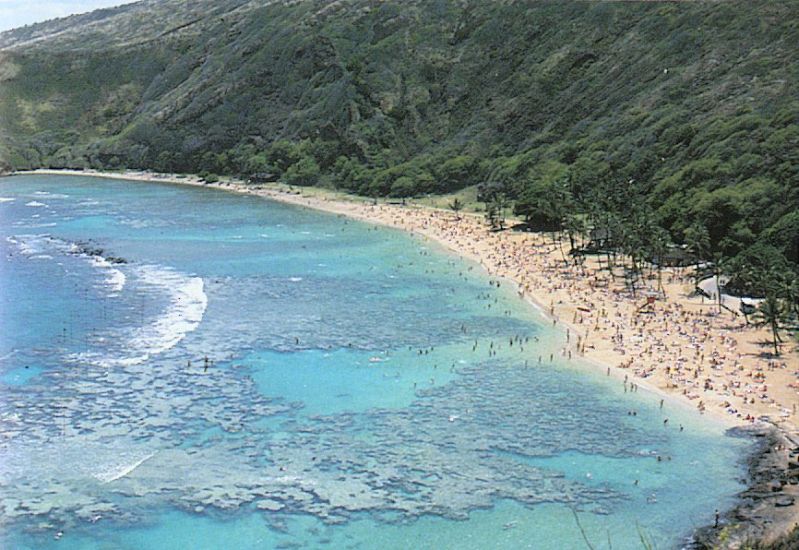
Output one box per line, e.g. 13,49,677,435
10,170,799,547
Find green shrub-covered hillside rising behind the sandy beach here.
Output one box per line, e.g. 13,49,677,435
0,0,799,332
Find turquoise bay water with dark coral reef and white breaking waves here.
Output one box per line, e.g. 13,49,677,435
0,176,749,549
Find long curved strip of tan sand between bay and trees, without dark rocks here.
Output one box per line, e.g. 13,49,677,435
10,170,799,535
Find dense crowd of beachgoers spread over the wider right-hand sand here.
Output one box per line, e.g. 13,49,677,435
332,199,799,421
